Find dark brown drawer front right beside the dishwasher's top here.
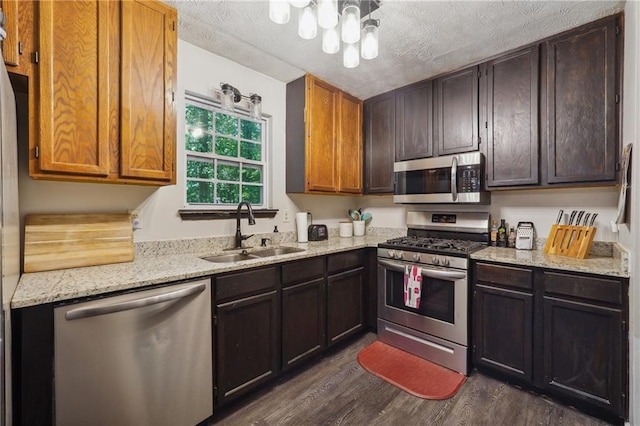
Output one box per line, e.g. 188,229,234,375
215,266,278,303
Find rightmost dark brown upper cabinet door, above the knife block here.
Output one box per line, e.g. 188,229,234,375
546,19,619,183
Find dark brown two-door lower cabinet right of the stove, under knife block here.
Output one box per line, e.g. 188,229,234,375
473,261,629,422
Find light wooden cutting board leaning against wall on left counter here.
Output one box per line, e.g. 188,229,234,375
24,214,133,272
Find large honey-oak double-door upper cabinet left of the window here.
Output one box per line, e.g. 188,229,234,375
29,0,177,185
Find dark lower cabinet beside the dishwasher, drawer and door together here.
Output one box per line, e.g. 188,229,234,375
214,267,280,405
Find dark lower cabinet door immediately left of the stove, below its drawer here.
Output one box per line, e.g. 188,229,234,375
327,268,364,346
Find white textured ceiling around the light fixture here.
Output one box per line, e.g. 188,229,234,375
164,0,624,99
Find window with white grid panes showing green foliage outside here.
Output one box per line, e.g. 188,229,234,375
184,93,267,208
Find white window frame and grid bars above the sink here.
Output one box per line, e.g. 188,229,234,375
182,91,271,210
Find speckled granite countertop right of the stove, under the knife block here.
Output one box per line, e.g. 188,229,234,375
471,247,629,278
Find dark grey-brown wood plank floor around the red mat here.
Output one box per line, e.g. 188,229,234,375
211,333,608,426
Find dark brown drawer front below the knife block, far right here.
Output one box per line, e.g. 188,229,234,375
543,272,622,305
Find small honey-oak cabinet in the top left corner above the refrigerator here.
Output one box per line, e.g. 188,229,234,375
0,0,33,76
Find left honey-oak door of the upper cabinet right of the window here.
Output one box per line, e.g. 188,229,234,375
305,76,338,192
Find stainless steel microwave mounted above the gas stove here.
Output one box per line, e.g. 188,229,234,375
393,152,491,204
